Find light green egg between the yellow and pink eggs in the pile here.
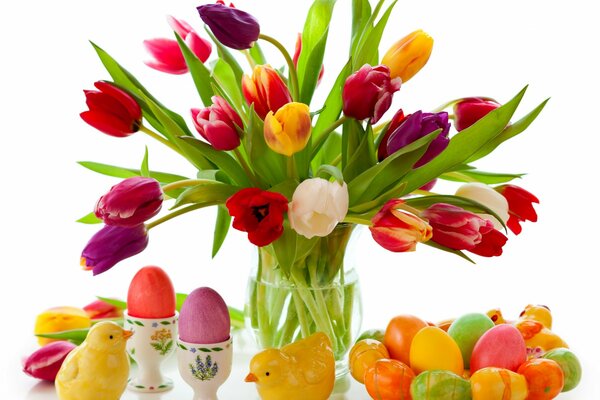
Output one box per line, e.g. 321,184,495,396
448,313,494,369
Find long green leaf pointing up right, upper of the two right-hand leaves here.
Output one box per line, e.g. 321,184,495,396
403,87,527,194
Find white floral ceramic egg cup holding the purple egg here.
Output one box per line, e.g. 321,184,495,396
177,337,233,400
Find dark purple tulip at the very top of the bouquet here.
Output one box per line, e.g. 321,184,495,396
197,3,260,50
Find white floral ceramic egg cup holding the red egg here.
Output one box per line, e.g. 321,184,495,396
124,311,178,393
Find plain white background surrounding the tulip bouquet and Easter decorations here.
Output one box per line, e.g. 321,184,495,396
0,0,600,400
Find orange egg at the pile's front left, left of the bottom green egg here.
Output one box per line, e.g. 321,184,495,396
365,359,415,400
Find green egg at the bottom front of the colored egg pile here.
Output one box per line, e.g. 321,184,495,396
410,370,471,400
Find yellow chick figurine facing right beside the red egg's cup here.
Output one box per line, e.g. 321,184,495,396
55,321,133,400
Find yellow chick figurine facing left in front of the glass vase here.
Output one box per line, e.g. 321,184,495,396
245,332,335,400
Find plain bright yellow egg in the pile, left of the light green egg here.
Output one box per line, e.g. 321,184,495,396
410,326,464,375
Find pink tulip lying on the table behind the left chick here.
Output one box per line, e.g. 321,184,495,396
23,340,77,382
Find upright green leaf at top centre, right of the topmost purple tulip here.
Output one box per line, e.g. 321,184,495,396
297,0,335,104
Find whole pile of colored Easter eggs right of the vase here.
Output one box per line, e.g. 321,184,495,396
349,305,581,400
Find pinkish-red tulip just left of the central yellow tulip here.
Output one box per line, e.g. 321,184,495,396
192,96,244,150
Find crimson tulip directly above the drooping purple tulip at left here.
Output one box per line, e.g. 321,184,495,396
94,176,163,227
